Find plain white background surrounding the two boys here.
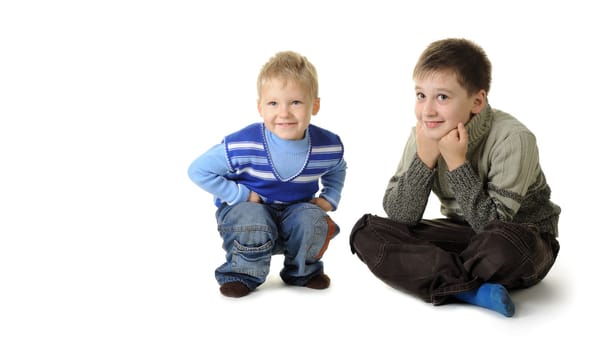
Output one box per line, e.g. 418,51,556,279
0,0,603,349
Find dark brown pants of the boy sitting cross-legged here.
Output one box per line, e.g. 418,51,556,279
350,214,559,305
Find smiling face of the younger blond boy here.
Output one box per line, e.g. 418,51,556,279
258,78,320,140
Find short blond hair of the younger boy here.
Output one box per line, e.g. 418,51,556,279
257,51,318,98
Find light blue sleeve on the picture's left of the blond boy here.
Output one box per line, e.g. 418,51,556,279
188,144,250,205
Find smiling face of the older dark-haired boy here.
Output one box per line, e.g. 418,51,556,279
415,72,486,140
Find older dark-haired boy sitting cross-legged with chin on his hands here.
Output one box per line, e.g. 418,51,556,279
350,39,561,317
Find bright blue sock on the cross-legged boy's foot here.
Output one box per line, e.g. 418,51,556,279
454,283,515,317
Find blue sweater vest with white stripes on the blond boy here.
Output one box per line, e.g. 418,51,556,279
222,123,343,205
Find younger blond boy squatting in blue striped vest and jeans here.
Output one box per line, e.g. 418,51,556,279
188,51,346,298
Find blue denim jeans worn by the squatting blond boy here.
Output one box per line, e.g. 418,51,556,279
216,202,339,290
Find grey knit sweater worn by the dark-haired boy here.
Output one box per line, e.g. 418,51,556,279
383,106,561,236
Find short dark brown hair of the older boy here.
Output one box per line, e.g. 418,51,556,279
413,38,492,94
